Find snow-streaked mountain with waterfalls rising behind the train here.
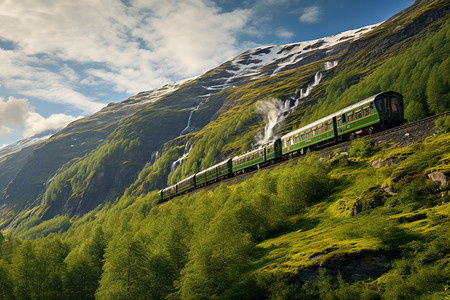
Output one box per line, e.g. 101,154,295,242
0,0,450,228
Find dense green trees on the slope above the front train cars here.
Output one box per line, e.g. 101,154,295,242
302,15,450,125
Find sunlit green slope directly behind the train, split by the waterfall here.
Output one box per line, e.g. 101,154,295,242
132,11,450,190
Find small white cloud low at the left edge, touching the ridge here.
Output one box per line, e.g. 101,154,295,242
0,97,78,137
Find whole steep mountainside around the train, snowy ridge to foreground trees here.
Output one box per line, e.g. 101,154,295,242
0,0,450,300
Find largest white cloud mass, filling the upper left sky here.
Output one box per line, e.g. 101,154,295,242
0,0,251,113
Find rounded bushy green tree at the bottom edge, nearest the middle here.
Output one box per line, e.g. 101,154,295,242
180,212,253,299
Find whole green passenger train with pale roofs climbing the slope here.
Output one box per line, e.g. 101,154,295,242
160,91,406,202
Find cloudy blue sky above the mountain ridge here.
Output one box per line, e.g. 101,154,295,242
0,0,414,148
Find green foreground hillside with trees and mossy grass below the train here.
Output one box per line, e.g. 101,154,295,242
0,117,450,299
